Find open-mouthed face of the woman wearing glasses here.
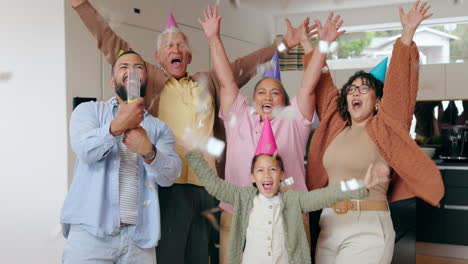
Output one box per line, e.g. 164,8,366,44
346,77,380,125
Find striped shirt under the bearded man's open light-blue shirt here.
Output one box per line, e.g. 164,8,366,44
118,134,138,225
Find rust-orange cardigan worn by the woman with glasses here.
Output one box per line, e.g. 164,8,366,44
303,39,444,206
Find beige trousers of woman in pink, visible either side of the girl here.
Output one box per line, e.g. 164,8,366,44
219,210,310,264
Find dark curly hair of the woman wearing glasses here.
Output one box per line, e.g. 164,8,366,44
338,71,384,124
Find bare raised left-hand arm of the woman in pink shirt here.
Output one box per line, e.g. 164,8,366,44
198,6,239,115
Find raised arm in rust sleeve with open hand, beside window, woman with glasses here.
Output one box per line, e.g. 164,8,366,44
377,0,432,130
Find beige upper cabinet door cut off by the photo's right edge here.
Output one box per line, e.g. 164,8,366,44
445,63,468,99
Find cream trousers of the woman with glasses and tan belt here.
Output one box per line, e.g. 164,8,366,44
315,208,395,264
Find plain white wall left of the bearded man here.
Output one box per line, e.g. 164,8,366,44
0,0,67,263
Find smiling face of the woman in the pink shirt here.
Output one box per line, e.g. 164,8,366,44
254,78,285,119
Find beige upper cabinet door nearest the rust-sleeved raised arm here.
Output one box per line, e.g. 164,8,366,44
417,64,445,100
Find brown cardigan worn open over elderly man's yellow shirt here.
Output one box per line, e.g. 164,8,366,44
72,0,278,178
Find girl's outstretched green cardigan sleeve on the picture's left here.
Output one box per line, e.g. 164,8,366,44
185,150,239,205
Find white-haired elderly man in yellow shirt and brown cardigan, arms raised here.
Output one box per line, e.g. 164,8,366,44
71,0,308,264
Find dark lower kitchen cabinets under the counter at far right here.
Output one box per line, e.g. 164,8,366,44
417,165,468,246
